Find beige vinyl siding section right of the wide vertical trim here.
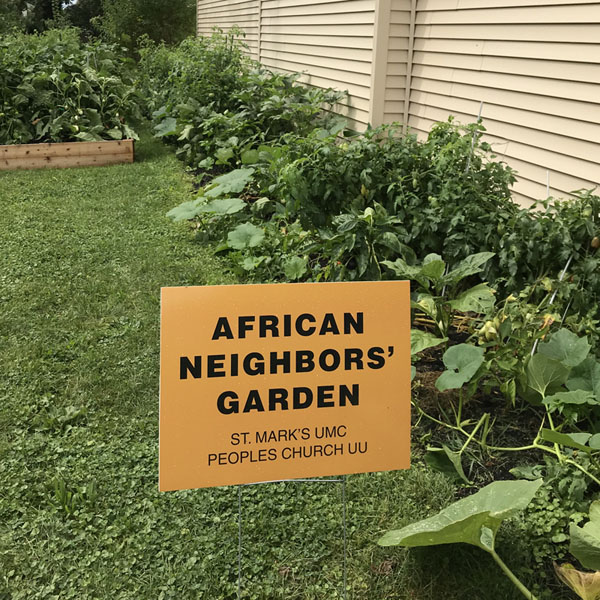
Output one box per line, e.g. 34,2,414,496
406,0,600,204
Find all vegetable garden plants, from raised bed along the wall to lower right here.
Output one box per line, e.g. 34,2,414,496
0,25,600,598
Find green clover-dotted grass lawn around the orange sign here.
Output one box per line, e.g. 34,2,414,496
0,134,544,600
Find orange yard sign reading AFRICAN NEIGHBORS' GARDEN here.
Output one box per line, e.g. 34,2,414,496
159,281,410,491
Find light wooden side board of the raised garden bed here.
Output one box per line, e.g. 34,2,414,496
0,140,134,171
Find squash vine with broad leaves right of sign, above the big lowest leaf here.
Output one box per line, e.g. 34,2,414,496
416,329,600,485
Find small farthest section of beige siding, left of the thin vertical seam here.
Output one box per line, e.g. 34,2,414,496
196,0,260,59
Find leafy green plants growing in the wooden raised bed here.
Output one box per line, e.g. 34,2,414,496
0,30,139,144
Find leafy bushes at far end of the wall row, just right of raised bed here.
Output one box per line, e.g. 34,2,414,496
140,28,340,168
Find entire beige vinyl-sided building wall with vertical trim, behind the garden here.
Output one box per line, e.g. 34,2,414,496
198,0,600,204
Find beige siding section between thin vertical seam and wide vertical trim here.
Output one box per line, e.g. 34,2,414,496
260,0,375,129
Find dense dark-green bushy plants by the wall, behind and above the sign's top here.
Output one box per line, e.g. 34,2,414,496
262,123,512,237
